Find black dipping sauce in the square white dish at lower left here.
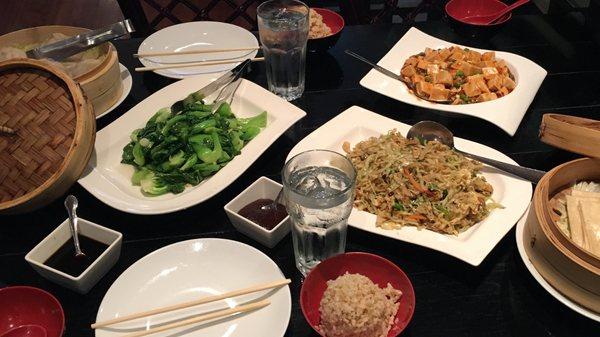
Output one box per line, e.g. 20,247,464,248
44,234,108,277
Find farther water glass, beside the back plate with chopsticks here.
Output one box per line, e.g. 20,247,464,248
256,0,308,101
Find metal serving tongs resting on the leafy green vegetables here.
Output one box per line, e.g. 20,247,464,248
171,59,252,115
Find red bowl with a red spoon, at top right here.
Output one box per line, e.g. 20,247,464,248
446,0,512,27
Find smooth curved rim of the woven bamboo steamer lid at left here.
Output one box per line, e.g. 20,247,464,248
0,58,95,211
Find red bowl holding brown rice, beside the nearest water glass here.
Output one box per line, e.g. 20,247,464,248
300,253,415,337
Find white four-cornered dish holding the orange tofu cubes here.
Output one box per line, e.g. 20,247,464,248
360,27,547,136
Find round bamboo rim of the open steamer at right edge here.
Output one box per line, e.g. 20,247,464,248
532,158,600,276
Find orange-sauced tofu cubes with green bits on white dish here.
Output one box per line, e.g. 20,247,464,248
400,46,517,104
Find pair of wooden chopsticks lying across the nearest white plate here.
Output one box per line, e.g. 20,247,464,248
91,279,291,337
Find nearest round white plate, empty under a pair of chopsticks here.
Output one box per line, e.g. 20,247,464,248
96,239,292,337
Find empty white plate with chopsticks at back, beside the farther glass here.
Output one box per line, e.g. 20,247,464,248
138,21,258,79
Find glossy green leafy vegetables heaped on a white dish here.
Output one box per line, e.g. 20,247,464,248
121,98,267,196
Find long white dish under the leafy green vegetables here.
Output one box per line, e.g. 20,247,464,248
79,77,306,214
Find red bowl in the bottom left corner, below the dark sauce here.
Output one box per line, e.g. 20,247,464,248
0,286,65,337
